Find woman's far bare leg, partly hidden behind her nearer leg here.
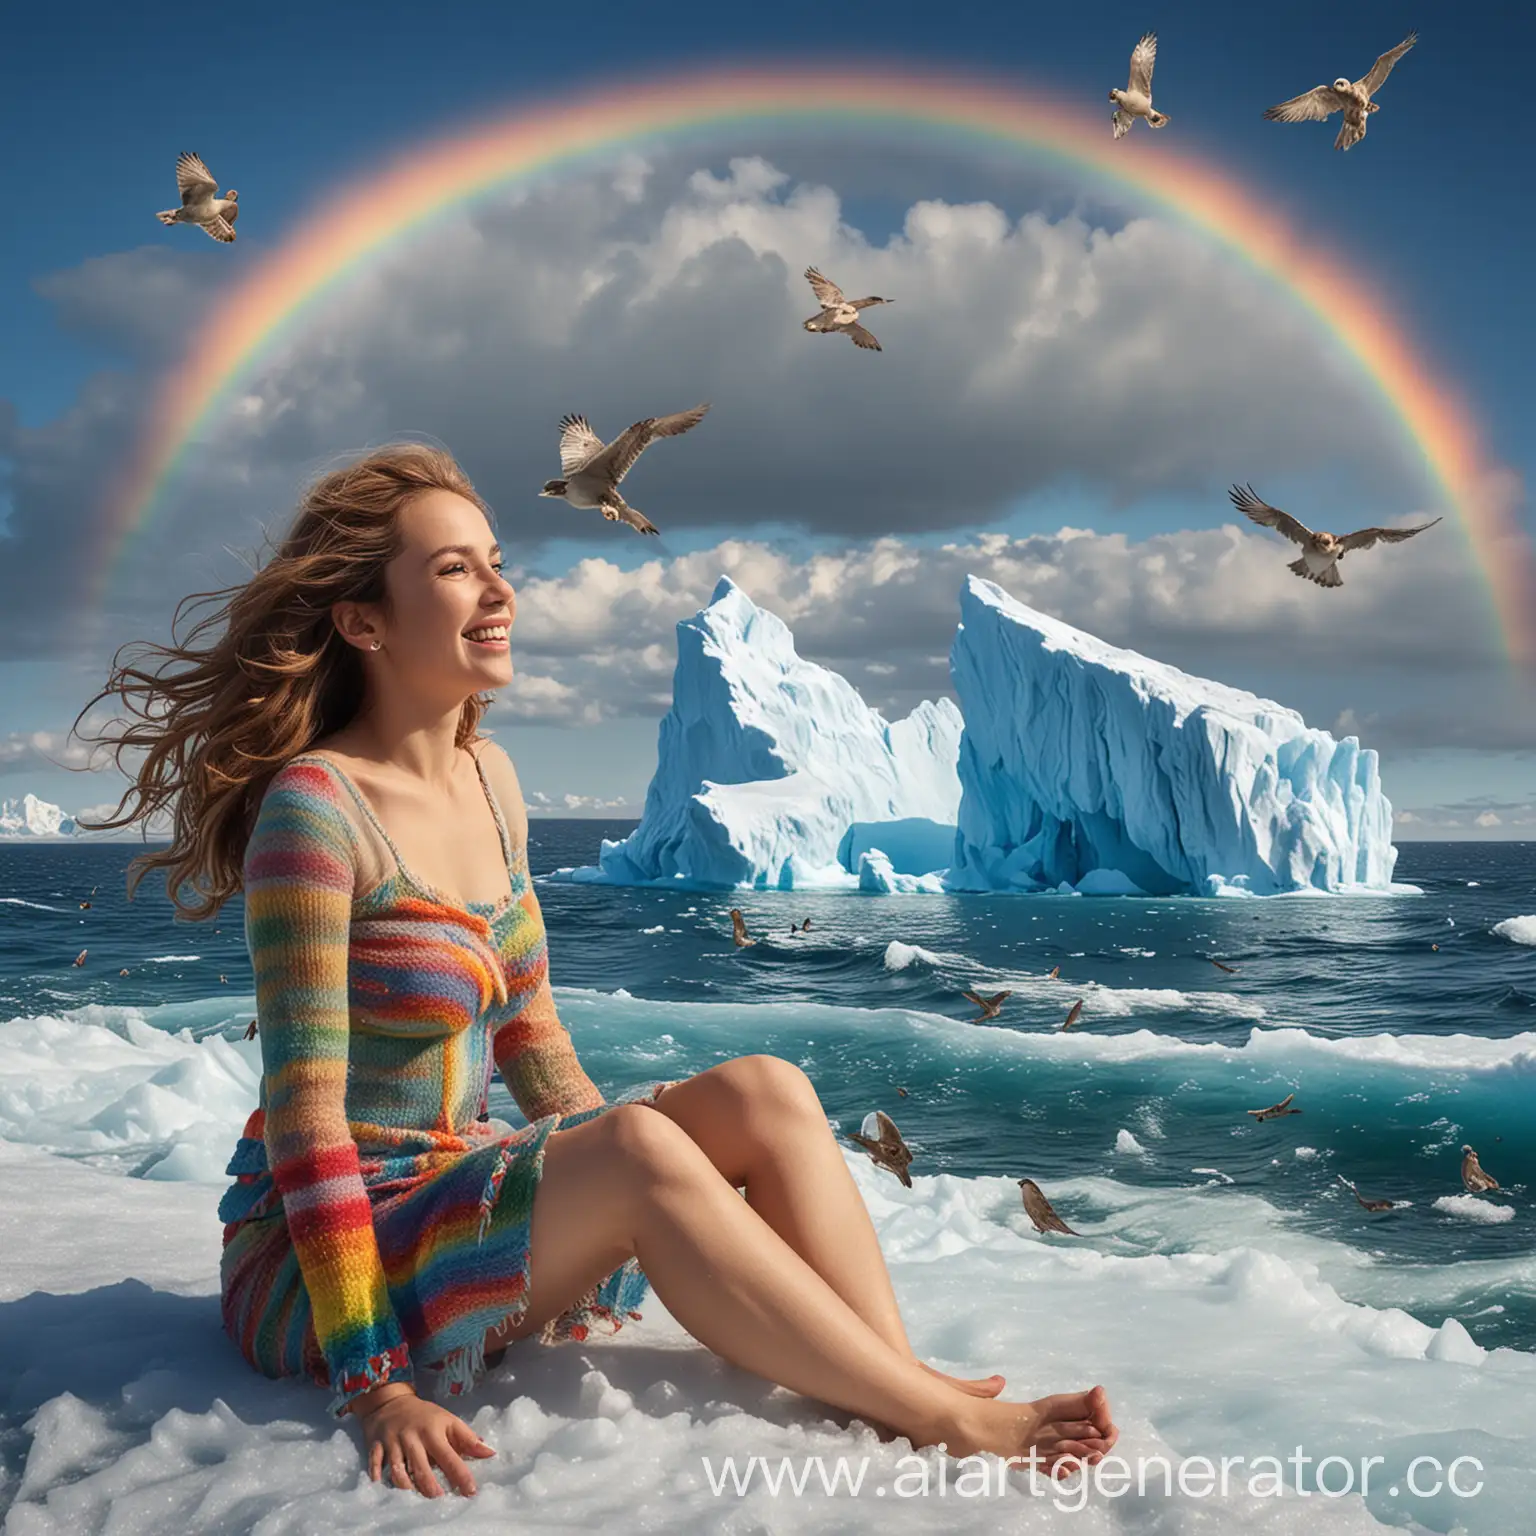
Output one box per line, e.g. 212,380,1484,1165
654,1055,1003,1396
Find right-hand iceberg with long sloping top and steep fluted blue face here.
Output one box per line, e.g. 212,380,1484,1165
946,576,1415,895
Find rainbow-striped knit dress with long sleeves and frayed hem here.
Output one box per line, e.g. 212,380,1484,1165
218,743,665,1416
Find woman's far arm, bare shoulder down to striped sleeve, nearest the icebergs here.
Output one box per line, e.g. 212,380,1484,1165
479,742,604,1121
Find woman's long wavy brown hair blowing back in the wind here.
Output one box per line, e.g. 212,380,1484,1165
71,442,490,919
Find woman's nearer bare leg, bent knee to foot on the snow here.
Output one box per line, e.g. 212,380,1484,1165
485,1104,1114,1464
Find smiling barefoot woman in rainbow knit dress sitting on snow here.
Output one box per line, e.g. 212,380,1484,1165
62,444,1117,1496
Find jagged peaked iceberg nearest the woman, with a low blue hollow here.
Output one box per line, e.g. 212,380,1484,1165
586,576,963,889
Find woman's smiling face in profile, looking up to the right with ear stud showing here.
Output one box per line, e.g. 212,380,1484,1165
364,490,518,697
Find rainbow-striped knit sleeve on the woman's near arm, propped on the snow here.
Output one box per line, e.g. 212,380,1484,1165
244,763,413,1416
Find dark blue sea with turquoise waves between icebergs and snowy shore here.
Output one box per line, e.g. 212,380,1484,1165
0,820,1536,1350
